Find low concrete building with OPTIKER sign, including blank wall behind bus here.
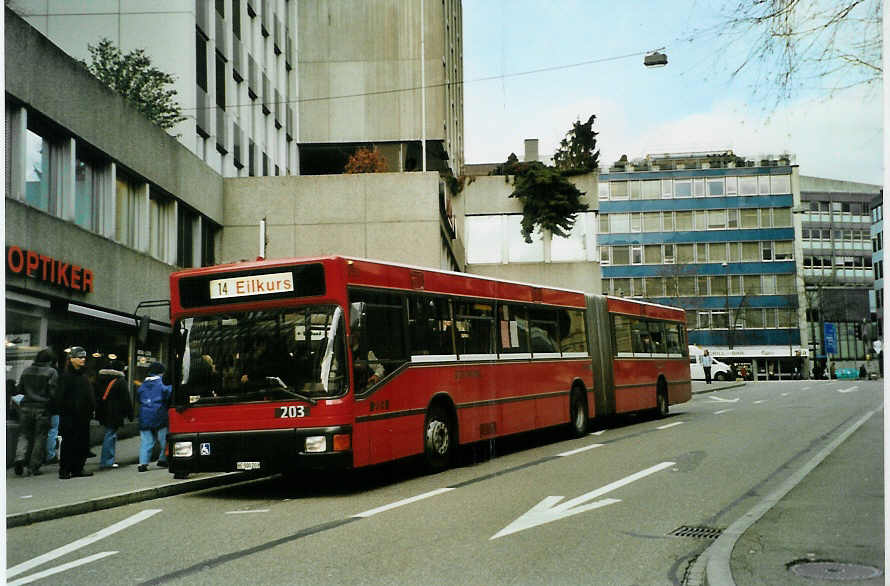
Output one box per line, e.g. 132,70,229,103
4,9,464,388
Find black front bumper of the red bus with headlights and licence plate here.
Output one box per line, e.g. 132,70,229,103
167,426,352,475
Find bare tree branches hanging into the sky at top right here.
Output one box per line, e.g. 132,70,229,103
691,0,883,104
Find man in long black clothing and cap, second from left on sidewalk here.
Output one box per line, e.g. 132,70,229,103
58,346,96,480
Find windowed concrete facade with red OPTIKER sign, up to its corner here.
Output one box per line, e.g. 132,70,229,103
4,9,223,381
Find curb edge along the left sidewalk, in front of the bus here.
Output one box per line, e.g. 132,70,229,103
6,472,260,529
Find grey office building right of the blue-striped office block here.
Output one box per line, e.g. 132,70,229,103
800,176,881,369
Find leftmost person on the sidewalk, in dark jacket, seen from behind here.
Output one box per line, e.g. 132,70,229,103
15,348,59,476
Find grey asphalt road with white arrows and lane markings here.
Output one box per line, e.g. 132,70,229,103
7,381,883,585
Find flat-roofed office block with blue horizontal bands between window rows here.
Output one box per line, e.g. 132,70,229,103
598,151,808,379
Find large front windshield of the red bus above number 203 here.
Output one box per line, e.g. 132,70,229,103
174,305,348,405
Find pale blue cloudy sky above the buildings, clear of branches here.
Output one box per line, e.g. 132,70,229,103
463,0,884,184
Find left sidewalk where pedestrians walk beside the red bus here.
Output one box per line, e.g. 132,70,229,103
6,428,256,528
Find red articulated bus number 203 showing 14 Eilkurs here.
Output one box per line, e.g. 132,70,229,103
167,256,691,478
